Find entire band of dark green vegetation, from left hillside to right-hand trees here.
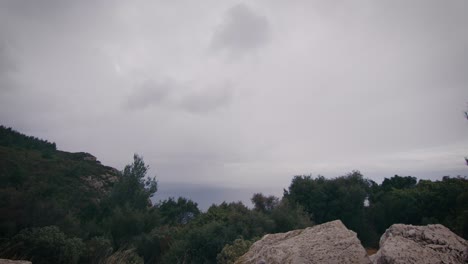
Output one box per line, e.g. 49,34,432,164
0,127,468,263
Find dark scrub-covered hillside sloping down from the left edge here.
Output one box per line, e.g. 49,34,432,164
0,126,119,237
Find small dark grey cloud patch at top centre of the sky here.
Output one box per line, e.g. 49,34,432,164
212,4,270,54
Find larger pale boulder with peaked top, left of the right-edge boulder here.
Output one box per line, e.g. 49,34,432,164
236,220,371,264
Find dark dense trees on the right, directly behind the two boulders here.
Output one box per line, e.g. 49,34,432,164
284,171,468,247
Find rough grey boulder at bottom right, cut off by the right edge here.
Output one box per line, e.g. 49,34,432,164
370,224,468,264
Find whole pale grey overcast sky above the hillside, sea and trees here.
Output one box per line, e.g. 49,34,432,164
0,0,468,194
